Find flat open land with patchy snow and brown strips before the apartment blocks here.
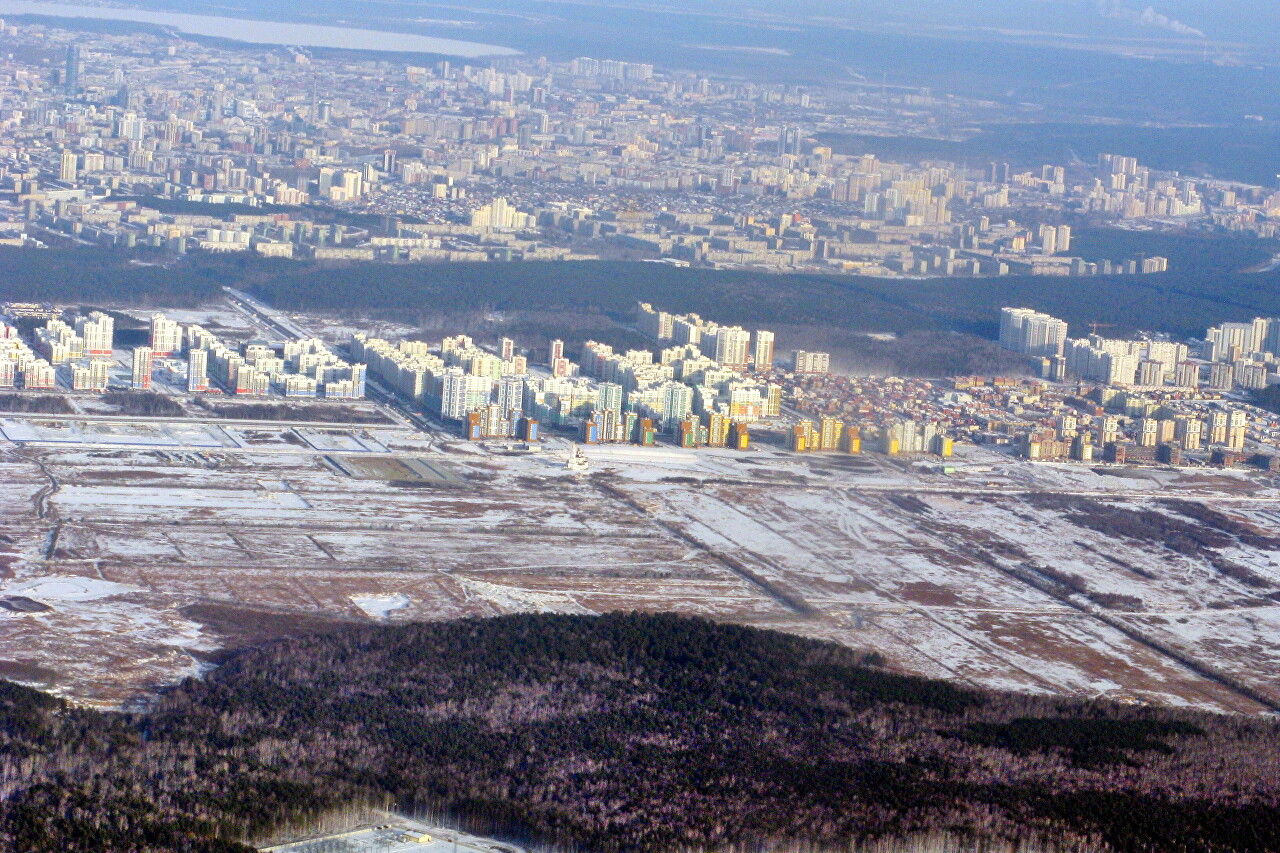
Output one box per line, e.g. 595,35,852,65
0,399,1280,712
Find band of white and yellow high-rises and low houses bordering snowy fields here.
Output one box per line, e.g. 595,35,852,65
0,293,1280,469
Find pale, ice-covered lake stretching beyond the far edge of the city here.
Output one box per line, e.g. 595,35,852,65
0,0,520,56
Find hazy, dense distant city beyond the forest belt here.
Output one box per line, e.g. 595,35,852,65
0,15,1280,277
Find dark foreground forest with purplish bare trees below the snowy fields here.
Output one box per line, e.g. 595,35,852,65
0,613,1280,853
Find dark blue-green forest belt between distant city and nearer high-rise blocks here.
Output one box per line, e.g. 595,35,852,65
0,229,1280,338
